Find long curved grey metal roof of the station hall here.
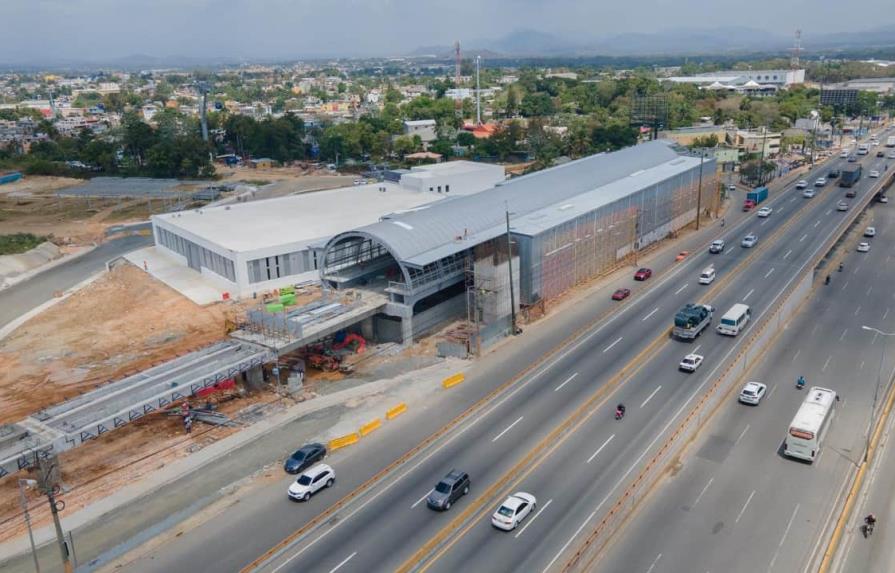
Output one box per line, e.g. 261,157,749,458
340,140,690,267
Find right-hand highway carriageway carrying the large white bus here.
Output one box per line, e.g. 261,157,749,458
597,161,895,573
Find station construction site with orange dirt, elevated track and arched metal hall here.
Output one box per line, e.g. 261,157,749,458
0,142,719,540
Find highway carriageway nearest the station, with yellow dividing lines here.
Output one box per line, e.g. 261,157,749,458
128,130,895,571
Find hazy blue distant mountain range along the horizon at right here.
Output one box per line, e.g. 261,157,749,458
410,26,895,57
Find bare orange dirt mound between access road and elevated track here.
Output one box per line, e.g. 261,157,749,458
0,265,240,423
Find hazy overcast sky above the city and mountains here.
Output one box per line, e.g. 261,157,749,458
7,0,895,63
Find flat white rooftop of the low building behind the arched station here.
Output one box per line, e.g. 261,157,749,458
152,182,444,252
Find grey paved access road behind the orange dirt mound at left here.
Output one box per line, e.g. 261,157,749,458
0,235,152,327
